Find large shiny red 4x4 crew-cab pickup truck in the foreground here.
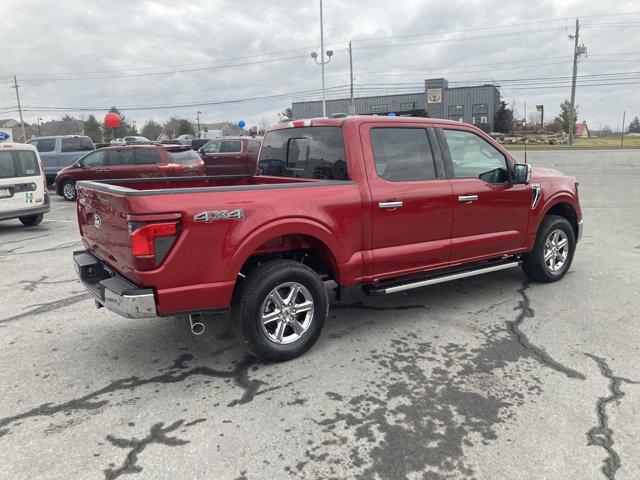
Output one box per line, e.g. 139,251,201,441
74,116,582,361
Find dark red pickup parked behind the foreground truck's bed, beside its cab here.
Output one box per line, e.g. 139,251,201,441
198,137,262,175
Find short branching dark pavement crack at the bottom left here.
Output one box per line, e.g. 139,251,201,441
104,420,194,480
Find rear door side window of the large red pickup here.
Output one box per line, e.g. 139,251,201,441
370,127,436,182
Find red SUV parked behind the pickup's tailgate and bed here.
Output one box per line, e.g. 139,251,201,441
55,145,204,201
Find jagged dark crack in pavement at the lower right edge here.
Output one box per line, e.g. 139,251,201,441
585,353,640,480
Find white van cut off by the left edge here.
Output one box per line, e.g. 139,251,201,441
0,143,50,227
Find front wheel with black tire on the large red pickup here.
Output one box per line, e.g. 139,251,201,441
522,215,576,283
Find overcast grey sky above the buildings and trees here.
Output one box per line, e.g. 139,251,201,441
0,0,640,129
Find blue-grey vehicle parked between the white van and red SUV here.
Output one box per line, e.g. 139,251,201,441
27,135,95,183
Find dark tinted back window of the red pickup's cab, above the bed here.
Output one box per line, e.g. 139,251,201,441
258,127,349,180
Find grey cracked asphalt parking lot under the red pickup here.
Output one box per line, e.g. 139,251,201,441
0,150,640,480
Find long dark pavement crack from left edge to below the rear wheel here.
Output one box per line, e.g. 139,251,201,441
0,353,266,437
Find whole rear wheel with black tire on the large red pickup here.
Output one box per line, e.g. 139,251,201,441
232,260,329,362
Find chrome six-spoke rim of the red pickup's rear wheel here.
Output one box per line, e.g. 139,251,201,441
260,282,314,345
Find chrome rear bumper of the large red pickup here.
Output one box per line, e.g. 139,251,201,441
73,250,157,318
